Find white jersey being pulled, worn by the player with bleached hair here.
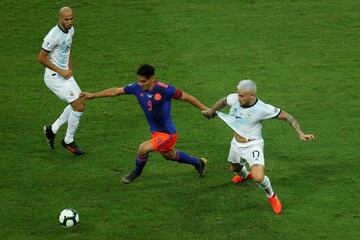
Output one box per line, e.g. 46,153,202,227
218,93,281,140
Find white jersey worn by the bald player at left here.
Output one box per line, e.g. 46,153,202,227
41,25,75,70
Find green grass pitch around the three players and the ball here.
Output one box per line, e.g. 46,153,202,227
0,0,360,240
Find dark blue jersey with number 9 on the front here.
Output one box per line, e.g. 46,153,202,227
124,81,182,134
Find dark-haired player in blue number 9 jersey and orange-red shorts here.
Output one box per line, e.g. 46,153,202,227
80,64,208,184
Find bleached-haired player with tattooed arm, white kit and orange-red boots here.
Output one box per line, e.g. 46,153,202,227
203,80,314,214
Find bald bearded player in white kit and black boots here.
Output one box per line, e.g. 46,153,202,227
38,7,85,155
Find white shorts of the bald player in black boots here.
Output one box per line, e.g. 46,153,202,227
44,69,81,103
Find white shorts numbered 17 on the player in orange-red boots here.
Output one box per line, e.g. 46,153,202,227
228,137,265,167
